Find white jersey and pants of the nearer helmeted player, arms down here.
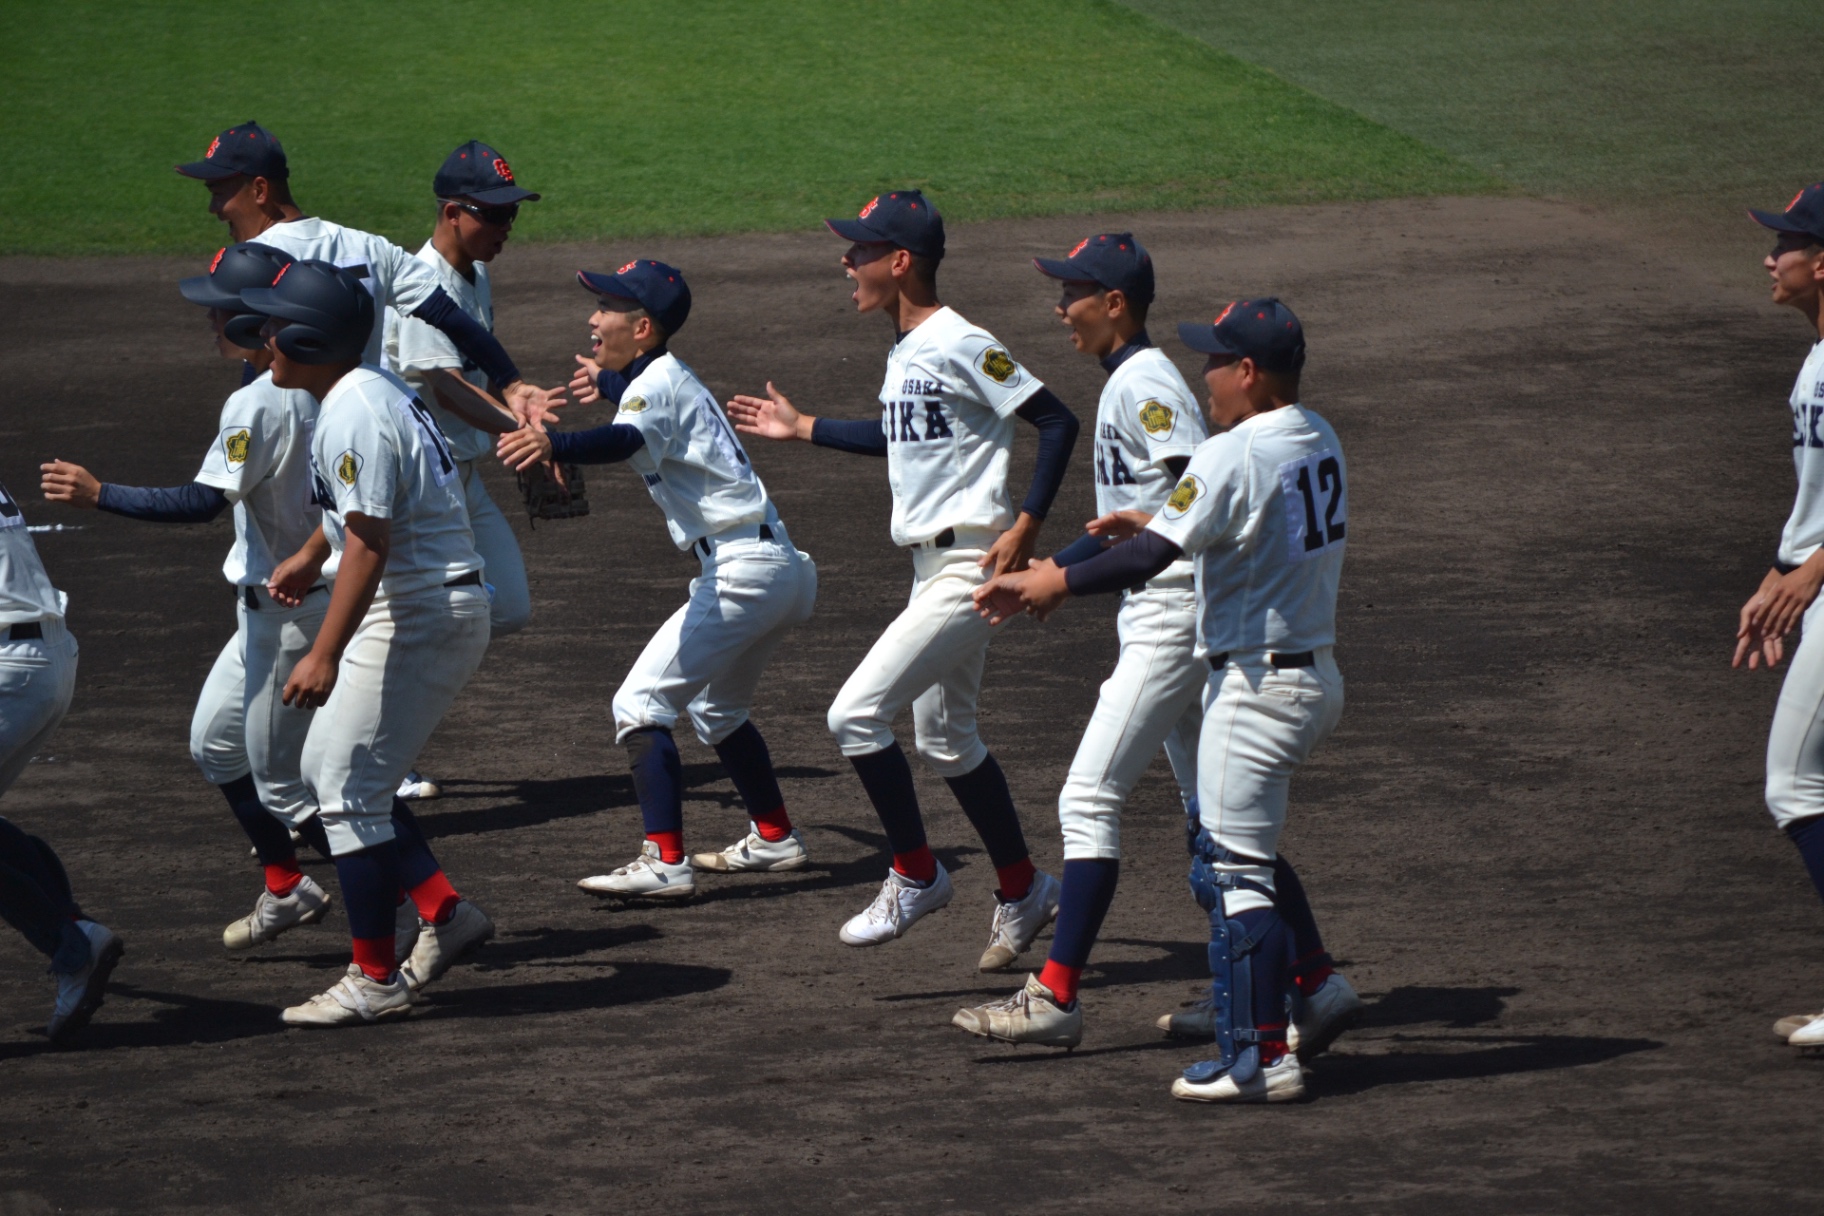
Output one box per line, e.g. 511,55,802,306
303,365,489,855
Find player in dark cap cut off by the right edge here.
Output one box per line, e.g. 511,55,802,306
1735,182,1824,1050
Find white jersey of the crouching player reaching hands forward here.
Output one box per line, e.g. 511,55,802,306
615,354,779,549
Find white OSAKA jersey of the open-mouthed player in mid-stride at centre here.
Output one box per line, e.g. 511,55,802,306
881,308,1045,545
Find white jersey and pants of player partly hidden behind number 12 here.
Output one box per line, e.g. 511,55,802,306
1058,346,1209,860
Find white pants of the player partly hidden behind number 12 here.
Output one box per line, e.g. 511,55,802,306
1058,587,1209,860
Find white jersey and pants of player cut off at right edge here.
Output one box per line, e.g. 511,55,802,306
1767,341,1824,828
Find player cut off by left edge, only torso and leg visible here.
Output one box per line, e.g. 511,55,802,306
0,485,126,1045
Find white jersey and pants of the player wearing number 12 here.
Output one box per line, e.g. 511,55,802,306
1147,405,1348,917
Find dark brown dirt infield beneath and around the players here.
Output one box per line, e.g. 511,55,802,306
0,201,1824,1214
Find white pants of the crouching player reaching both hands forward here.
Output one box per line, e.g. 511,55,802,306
615,525,817,747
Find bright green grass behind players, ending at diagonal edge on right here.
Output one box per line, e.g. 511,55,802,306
0,0,1501,253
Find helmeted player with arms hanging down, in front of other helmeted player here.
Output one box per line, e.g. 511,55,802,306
241,261,494,1026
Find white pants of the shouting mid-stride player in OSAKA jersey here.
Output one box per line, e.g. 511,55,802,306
830,529,1000,777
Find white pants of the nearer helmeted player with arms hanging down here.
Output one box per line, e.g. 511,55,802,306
303,585,487,857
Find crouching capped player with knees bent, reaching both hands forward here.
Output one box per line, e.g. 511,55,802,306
500,259,817,899
